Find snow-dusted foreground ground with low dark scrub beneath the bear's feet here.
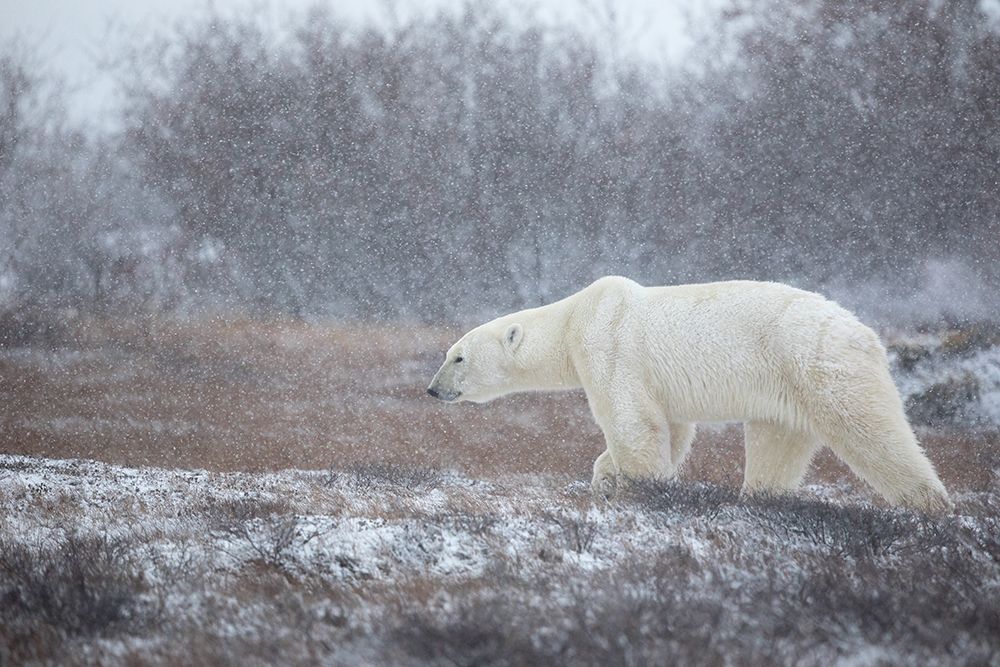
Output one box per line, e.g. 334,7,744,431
0,455,1000,665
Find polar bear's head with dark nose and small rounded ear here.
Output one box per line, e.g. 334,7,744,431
427,321,524,403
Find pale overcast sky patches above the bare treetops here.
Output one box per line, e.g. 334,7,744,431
0,0,721,124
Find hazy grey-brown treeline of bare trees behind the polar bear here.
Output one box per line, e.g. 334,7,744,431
0,0,1000,320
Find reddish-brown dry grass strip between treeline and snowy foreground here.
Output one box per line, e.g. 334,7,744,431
0,319,1000,500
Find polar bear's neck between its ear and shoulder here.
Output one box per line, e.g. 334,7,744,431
515,299,581,391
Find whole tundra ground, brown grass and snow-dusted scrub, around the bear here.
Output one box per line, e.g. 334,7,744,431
0,321,1000,665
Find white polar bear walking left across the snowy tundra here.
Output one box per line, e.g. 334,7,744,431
427,277,951,511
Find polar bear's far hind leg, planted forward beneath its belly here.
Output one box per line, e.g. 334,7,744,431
743,422,816,493
